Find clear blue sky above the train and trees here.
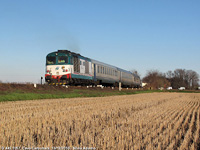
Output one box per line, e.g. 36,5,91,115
0,0,200,82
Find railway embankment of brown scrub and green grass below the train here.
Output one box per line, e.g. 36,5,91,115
0,83,200,102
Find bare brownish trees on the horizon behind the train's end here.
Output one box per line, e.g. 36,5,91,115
142,69,199,89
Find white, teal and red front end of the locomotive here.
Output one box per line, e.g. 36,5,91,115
45,50,73,84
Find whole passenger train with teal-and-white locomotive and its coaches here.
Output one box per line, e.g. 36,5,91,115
45,50,141,88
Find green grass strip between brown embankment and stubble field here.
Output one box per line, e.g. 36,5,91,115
0,88,200,102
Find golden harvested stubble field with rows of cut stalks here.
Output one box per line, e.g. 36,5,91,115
0,93,200,150
